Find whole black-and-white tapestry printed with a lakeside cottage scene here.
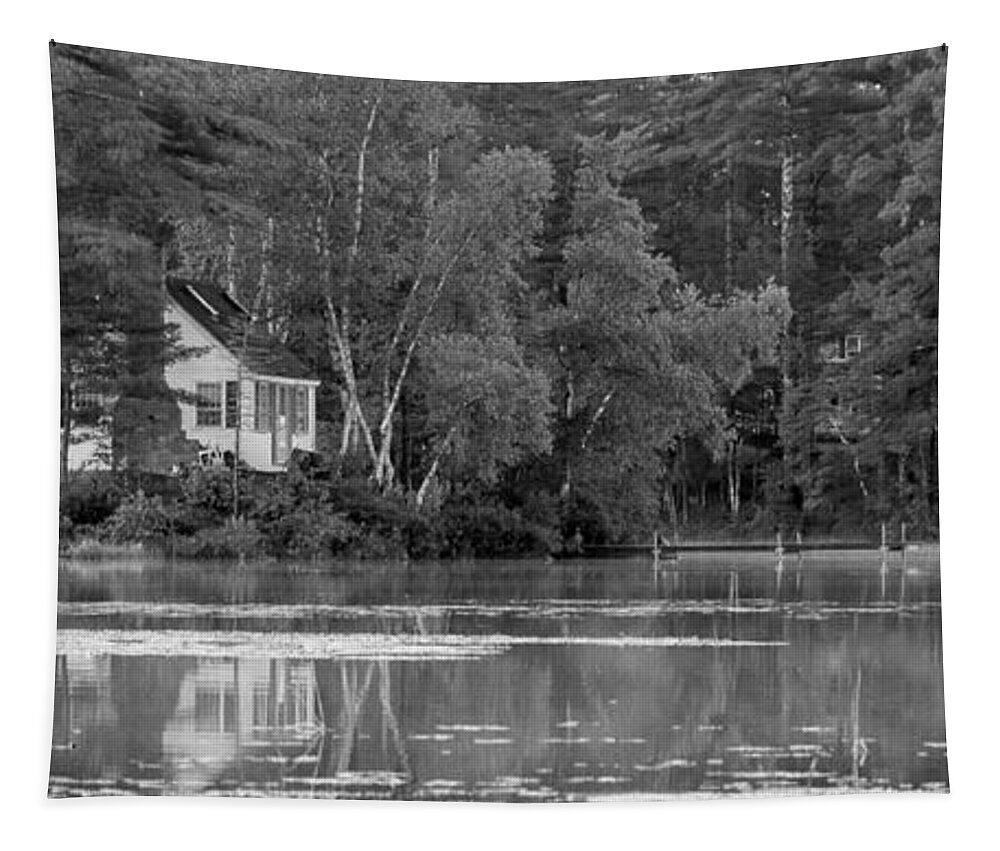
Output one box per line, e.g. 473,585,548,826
49,43,948,802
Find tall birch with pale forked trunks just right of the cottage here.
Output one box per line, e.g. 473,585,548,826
308,84,551,489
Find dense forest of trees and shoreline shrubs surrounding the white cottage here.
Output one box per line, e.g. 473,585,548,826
52,44,947,556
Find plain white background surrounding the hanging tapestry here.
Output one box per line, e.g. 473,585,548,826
0,0,1000,851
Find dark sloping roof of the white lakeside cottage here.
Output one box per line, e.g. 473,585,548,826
167,278,313,380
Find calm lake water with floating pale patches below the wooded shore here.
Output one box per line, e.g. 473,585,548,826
49,552,948,801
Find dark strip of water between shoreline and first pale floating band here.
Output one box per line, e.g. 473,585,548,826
58,553,940,606
